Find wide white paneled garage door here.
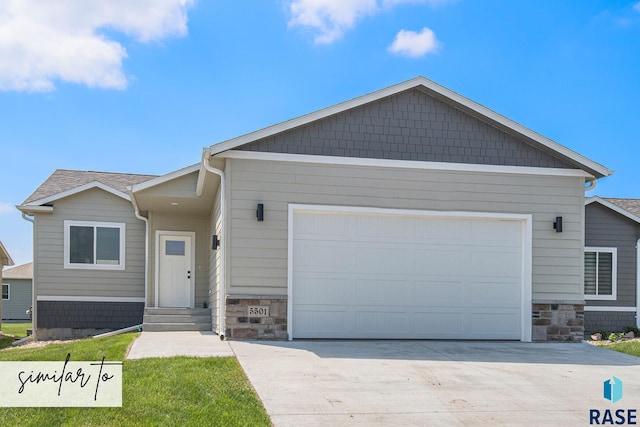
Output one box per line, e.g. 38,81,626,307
289,207,526,340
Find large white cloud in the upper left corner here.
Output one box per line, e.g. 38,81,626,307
0,0,194,92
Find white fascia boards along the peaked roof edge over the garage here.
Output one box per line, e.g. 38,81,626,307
210,76,613,176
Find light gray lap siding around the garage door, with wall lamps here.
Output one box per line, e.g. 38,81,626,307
227,159,584,301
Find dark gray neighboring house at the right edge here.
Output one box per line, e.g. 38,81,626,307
584,196,640,334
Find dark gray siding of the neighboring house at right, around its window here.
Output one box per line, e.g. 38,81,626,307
585,203,640,307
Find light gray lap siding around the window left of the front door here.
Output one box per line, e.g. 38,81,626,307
34,189,145,297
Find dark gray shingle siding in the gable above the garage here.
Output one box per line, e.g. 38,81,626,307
237,89,575,168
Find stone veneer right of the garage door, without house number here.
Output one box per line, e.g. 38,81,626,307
532,303,584,342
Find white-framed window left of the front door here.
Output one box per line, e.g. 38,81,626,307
64,221,125,270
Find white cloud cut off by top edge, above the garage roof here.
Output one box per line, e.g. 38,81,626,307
289,0,451,44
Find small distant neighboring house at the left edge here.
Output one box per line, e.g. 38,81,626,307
2,262,33,320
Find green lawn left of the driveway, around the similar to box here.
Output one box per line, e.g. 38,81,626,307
0,334,271,426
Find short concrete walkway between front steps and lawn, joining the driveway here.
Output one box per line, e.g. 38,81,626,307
127,331,235,359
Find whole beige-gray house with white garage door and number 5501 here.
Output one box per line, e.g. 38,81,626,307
18,77,611,341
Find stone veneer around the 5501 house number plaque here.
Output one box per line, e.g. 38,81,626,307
225,297,289,340
